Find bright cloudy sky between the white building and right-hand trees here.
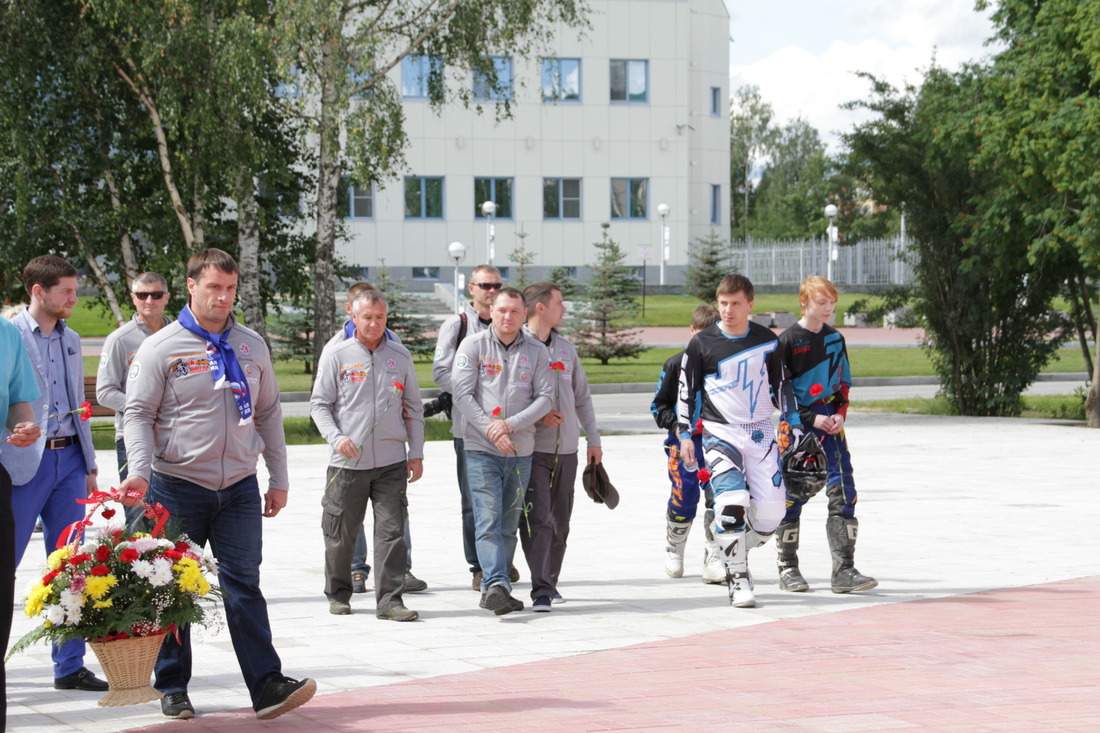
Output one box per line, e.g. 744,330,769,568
725,0,997,152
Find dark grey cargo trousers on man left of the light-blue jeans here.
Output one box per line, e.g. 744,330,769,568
321,461,408,613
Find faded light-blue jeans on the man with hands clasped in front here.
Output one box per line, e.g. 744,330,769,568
465,450,531,592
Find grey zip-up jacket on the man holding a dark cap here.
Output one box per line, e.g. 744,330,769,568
524,326,600,456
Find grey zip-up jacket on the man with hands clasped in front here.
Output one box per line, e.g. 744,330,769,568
452,327,553,456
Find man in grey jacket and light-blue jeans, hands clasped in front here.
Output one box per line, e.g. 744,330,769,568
452,287,553,615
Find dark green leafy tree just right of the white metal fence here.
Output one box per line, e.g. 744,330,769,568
845,67,1063,415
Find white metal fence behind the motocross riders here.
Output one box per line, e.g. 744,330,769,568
730,239,913,285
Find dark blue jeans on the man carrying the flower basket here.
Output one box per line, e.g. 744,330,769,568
147,472,283,707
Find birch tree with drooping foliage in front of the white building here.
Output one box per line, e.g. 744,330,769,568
274,0,587,372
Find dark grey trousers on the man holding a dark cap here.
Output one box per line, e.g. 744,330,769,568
519,451,578,599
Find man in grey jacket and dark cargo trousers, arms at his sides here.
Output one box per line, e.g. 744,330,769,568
309,289,424,621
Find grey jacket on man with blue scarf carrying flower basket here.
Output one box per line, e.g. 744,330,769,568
122,316,290,491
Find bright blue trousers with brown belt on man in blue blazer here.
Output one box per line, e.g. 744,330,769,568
9,442,88,678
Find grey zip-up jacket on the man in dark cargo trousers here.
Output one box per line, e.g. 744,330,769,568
309,337,424,470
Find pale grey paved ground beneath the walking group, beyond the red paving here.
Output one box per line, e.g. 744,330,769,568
8,413,1100,732
